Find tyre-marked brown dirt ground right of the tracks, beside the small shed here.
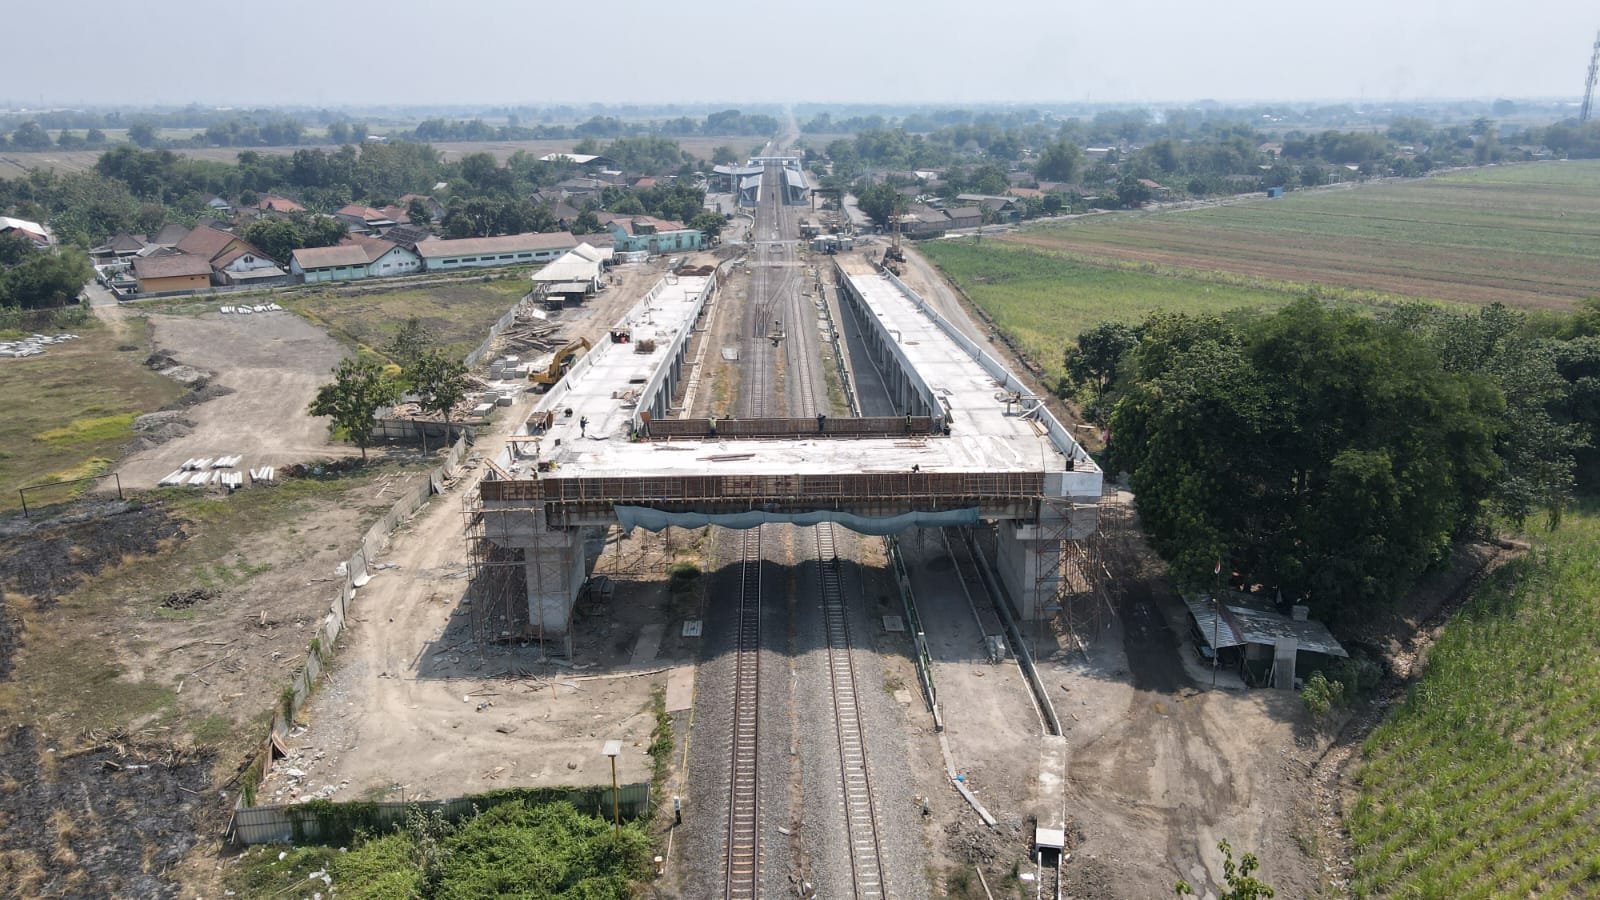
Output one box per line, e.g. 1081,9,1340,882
1040,531,1338,897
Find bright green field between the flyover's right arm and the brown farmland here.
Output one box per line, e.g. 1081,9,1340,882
918,240,1296,378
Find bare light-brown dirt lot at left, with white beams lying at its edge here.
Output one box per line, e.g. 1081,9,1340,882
117,312,355,490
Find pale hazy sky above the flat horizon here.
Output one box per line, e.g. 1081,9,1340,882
12,0,1600,106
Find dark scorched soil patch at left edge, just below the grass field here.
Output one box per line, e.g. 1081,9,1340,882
0,501,187,609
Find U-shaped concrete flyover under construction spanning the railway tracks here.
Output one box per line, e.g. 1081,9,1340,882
466,248,1101,641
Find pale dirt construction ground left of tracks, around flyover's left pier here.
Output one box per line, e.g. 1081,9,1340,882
261,264,713,802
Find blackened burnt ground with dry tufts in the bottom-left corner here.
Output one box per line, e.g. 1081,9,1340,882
0,727,221,897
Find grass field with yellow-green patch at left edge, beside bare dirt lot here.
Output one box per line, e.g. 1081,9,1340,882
0,319,184,511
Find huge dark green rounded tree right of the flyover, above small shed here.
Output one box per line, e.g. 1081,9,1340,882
1110,299,1504,618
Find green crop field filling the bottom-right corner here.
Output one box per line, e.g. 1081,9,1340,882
1347,504,1600,898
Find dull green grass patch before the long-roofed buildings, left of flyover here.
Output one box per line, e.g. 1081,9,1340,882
280,271,528,357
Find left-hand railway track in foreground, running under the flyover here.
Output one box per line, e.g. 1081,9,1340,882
723,527,762,900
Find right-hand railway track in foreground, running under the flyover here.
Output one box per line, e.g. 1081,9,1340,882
816,522,888,898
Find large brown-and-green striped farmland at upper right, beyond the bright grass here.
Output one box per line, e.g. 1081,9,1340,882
1002,160,1600,309
